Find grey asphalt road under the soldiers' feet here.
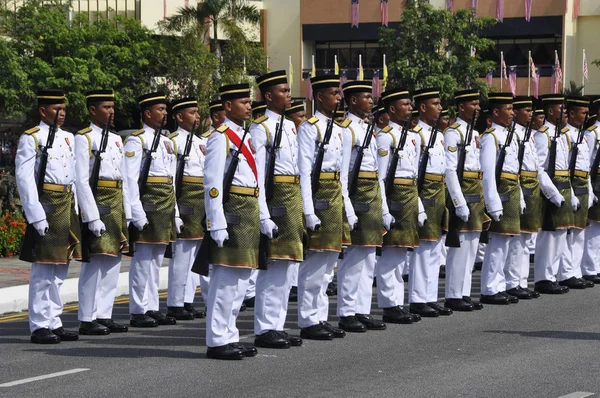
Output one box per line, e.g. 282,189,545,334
0,275,600,398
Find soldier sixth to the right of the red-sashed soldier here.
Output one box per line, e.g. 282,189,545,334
444,90,489,311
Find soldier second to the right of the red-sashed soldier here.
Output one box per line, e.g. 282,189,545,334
298,75,351,340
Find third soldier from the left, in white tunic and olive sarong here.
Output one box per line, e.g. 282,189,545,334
125,93,177,327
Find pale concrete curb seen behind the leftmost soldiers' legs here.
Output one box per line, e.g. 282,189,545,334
0,266,169,315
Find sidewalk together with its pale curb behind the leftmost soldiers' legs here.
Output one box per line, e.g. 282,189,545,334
0,256,169,315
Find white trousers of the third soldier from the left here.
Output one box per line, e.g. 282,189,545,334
129,243,167,314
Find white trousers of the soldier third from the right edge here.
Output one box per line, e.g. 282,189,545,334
533,229,567,282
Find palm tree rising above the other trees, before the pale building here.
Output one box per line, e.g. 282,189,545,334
166,0,262,59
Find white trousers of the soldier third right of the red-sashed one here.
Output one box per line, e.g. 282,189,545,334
337,246,376,316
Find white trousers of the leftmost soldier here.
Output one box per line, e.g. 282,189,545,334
28,263,69,332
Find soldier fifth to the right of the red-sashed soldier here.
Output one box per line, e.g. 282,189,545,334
408,88,452,317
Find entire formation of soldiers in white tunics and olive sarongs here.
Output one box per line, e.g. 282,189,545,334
16,71,600,359
